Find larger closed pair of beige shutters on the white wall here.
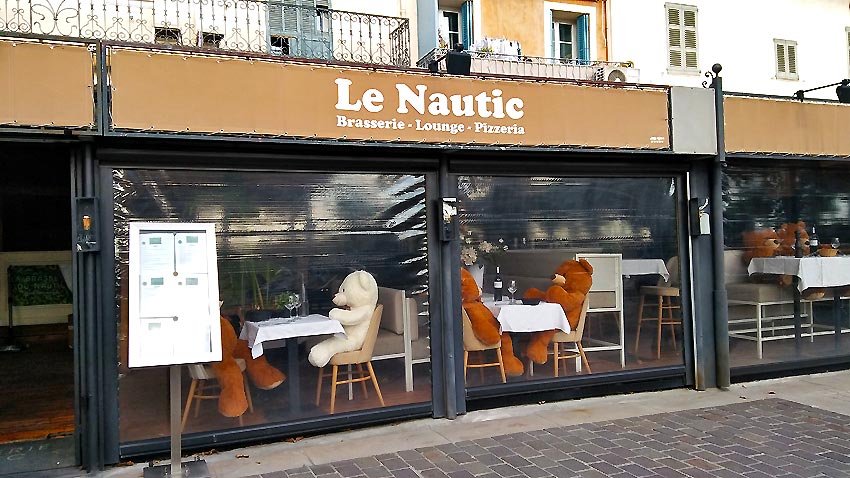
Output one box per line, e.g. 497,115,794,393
664,3,699,73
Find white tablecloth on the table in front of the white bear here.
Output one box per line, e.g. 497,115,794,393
239,314,345,358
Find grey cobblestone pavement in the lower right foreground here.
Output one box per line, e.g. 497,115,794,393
254,399,850,478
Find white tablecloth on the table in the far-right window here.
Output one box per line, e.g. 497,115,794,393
747,257,850,291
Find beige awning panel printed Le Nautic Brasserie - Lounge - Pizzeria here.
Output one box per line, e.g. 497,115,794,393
109,48,670,149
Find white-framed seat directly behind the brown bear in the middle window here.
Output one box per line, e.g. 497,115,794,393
575,252,626,367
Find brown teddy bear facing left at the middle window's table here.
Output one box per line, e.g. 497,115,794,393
524,259,593,364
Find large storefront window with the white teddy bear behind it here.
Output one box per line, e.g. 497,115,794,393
113,169,431,442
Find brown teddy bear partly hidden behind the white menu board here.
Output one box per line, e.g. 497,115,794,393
211,317,286,417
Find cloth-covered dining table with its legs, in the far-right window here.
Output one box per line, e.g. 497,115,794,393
747,255,850,350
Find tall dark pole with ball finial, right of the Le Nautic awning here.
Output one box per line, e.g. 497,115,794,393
707,63,730,389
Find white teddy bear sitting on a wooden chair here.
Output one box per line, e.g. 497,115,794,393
309,271,378,367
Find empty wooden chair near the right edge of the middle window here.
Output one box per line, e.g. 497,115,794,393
635,257,682,359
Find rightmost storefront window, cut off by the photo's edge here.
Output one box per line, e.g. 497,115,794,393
723,163,850,373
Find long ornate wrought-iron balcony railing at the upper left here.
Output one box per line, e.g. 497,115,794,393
0,0,410,67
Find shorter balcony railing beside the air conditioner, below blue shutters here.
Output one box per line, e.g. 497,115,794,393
417,48,637,83
